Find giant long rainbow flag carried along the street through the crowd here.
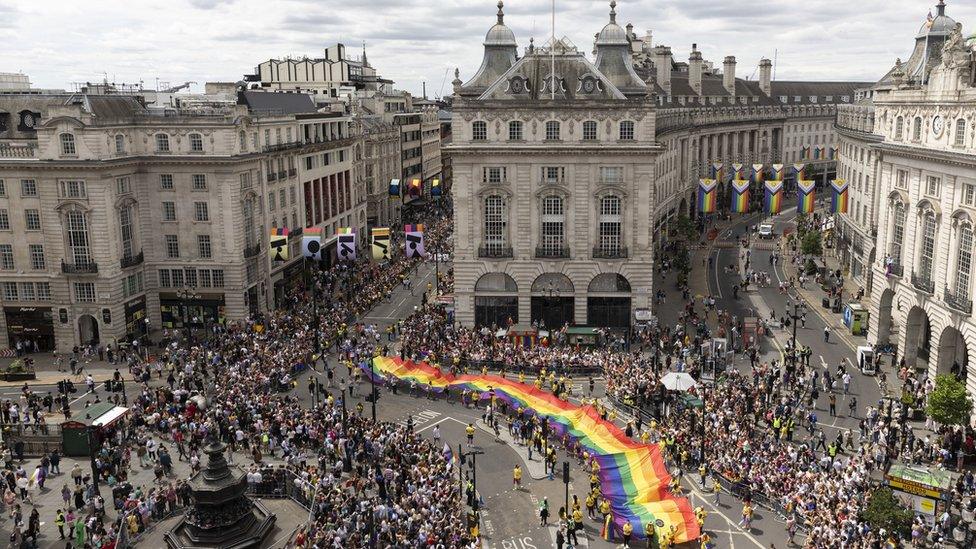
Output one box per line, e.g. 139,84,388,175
365,356,701,543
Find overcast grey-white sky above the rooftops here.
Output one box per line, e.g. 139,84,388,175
0,0,976,96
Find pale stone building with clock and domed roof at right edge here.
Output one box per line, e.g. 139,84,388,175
837,2,976,394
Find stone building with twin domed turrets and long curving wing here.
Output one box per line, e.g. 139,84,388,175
445,2,863,328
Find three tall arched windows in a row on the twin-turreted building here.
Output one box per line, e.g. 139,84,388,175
484,195,623,254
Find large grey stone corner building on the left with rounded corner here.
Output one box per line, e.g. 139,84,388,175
0,89,365,351
